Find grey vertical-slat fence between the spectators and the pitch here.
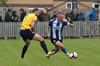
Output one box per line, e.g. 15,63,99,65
0,21,100,37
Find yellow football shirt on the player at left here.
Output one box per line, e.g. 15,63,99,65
20,13,37,30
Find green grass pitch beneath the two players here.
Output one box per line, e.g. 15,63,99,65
0,39,100,66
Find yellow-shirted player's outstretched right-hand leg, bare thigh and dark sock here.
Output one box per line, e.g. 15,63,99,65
33,34,48,54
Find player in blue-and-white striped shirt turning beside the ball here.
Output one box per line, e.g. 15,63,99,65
46,12,74,57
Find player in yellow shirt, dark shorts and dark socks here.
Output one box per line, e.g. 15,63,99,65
20,8,48,58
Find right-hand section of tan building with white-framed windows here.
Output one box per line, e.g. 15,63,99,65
53,0,100,8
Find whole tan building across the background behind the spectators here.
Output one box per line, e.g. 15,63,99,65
2,0,100,9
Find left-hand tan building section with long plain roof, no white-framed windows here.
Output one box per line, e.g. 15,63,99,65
5,0,53,9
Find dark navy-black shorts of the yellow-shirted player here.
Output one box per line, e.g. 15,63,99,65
20,30,35,41
